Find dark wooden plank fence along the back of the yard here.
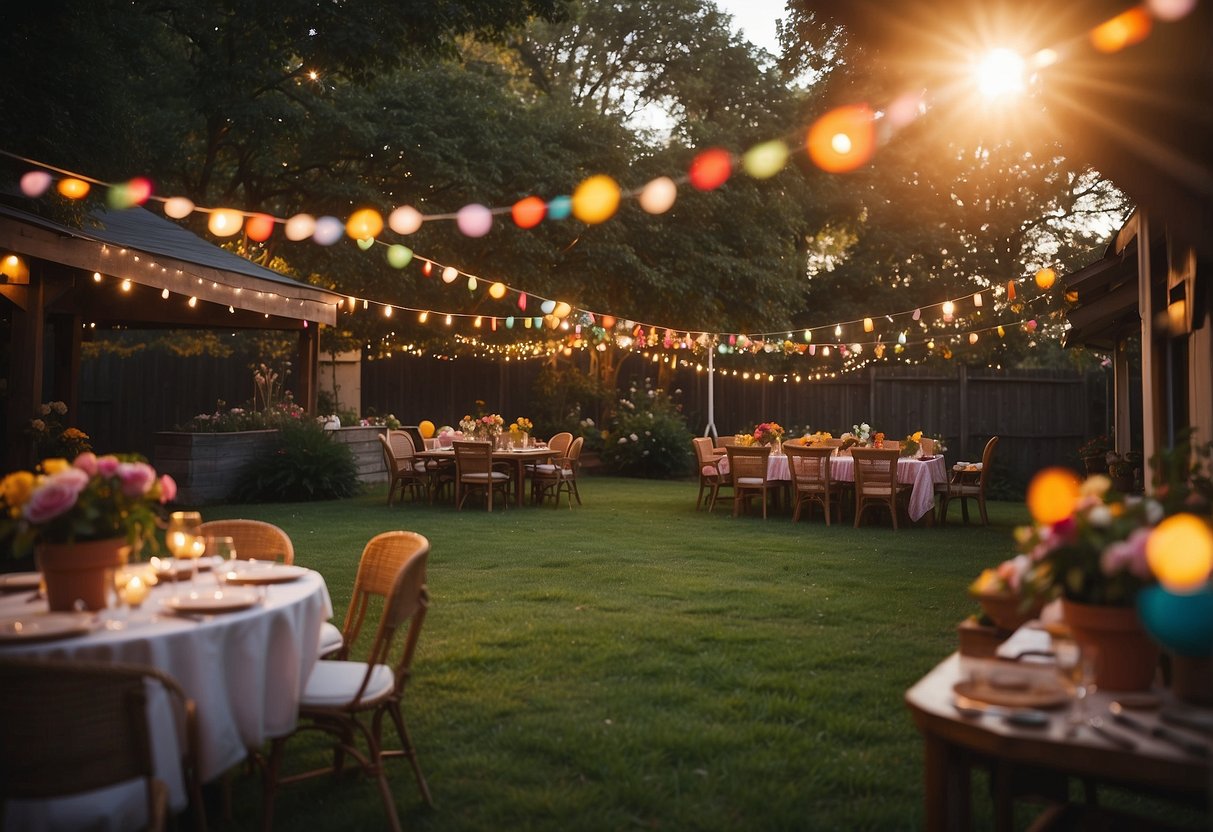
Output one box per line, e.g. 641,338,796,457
70,354,1107,491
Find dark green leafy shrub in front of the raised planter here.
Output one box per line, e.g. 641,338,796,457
232,420,361,502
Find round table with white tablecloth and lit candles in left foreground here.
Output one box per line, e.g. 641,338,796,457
0,562,332,831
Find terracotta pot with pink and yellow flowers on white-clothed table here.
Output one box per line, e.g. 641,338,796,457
0,451,177,610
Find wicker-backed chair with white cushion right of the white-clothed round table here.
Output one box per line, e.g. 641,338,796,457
262,531,433,832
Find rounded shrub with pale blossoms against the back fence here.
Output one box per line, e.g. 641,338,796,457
603,378,691,478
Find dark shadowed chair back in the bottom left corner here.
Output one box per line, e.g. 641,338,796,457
0,657,206,830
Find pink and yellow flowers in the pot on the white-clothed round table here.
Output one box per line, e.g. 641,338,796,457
0,451,177,557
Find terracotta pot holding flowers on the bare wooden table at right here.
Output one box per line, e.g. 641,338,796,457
1061,598,1158,690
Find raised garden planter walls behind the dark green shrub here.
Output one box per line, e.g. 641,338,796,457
153,427,387,506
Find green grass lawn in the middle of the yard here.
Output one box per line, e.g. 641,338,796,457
205,477,1154,831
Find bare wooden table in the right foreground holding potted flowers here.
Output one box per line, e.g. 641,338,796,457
905,654,1211,831
